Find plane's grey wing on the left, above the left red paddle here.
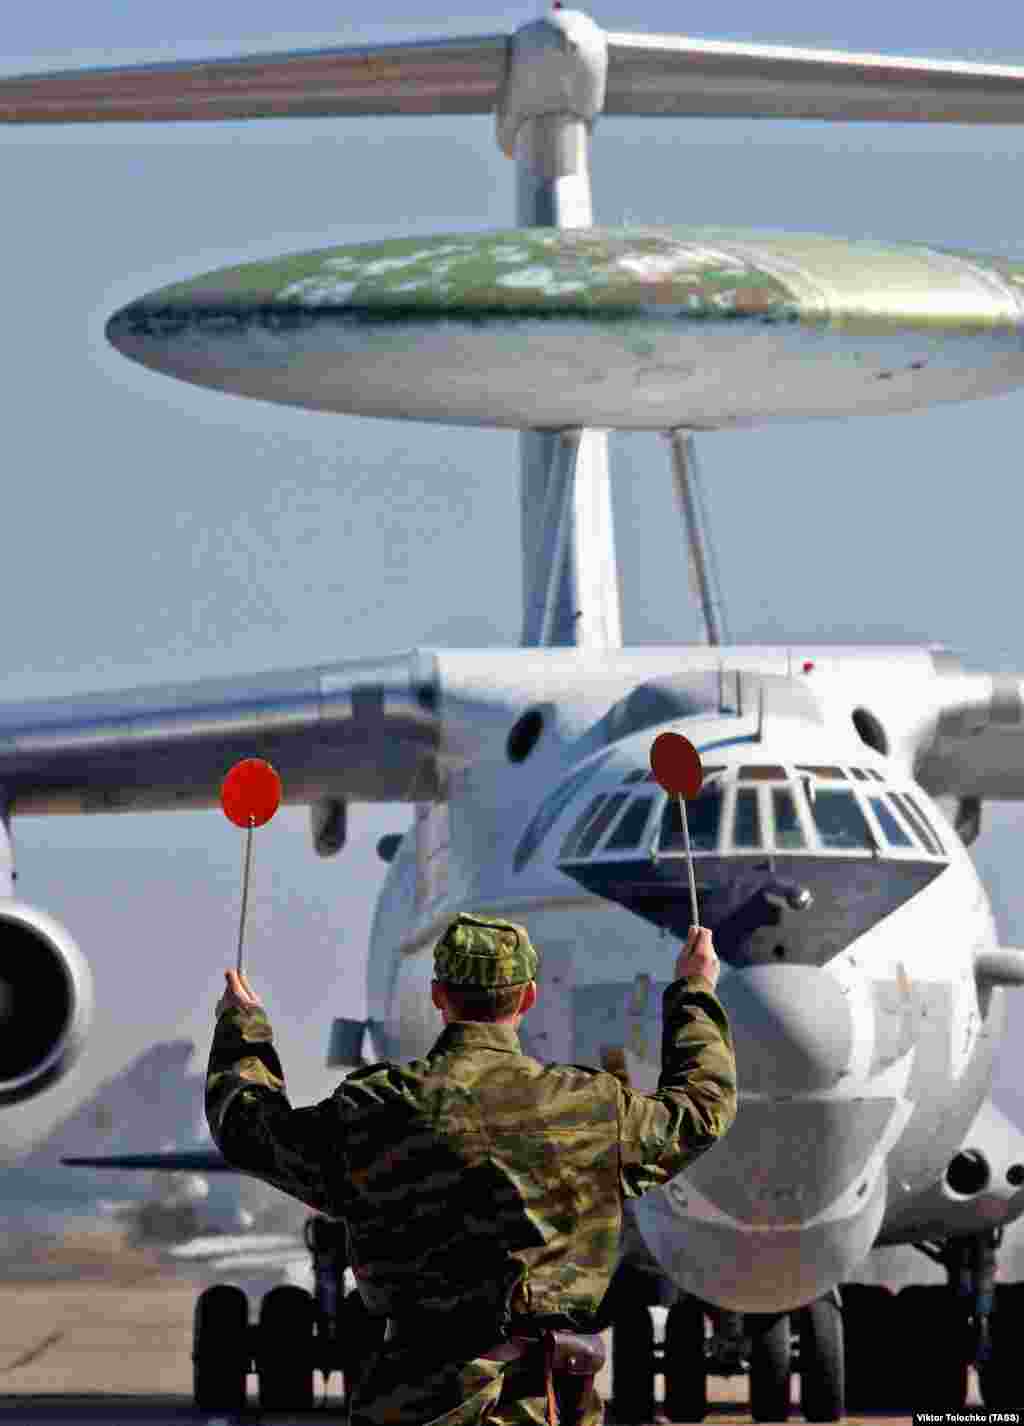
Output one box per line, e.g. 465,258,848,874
0,652,441,814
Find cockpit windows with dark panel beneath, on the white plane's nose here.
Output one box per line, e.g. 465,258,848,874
552,744,948,965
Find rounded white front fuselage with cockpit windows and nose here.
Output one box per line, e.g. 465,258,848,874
369,673,1003,1312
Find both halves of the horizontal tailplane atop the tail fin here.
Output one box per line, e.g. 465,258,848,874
0,33,1024,124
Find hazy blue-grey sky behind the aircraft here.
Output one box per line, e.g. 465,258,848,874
0,0,1024,1137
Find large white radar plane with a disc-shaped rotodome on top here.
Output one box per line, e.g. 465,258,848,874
0,10,1024,1420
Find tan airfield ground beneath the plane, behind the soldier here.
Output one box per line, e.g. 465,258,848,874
0,1233,978,1426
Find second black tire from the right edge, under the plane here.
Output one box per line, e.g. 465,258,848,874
896,1283,967,1412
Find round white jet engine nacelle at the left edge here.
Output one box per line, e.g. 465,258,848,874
0,900,93,1105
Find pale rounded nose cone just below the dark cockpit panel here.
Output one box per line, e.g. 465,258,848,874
719,965,854,1095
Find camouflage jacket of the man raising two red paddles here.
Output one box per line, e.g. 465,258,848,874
207,978,736,1340
